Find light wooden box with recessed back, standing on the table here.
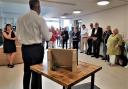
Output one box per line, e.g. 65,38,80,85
47,49,77,72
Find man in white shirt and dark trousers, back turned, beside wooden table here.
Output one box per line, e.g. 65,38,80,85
16,0,50,89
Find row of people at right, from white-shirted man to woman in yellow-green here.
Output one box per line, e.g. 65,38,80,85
80,23,123,65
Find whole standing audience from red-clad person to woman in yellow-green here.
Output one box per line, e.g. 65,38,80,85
45,22,123,65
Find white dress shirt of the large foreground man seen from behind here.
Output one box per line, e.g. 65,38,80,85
16,10,50,45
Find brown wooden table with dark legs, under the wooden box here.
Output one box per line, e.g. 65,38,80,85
31,62,102,89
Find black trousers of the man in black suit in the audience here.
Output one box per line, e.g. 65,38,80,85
93,40,101,57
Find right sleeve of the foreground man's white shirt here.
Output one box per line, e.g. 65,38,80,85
39,17,51,41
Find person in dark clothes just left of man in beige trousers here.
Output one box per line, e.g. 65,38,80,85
72,27,80,50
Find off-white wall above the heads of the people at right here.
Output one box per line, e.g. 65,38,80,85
82,5,128,35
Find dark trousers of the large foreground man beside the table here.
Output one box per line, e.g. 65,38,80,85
22,44,44,89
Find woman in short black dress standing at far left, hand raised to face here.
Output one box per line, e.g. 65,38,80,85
3,24,16,68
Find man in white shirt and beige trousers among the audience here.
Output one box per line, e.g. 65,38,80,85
80,24,88,53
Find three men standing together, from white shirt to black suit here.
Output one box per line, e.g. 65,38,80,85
80,23,103,58
